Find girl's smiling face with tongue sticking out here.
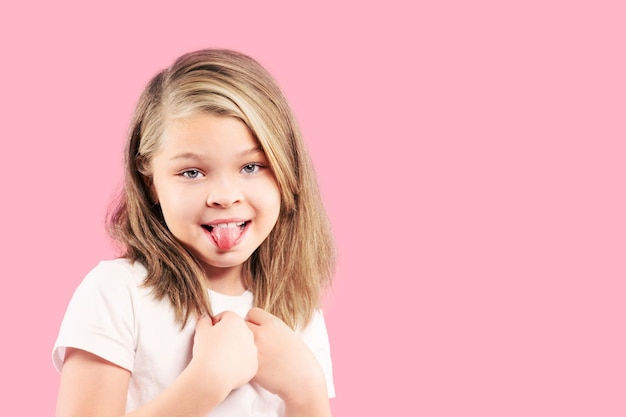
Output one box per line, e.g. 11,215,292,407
152,114,280,286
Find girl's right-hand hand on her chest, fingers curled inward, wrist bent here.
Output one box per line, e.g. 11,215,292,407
246,308,328,403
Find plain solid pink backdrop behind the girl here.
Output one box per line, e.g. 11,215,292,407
0,0,626,417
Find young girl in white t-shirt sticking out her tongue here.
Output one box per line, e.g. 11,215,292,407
53,50,334,417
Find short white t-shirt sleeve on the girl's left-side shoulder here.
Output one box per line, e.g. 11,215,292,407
52,262,136,372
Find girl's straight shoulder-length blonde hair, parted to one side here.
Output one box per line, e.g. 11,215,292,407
109,49,335,328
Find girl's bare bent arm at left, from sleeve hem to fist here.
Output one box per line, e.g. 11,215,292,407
56,312,258,417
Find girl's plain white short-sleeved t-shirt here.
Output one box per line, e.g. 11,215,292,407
52,259,335,417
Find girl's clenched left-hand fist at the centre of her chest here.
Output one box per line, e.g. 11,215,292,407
192,311,259,395
